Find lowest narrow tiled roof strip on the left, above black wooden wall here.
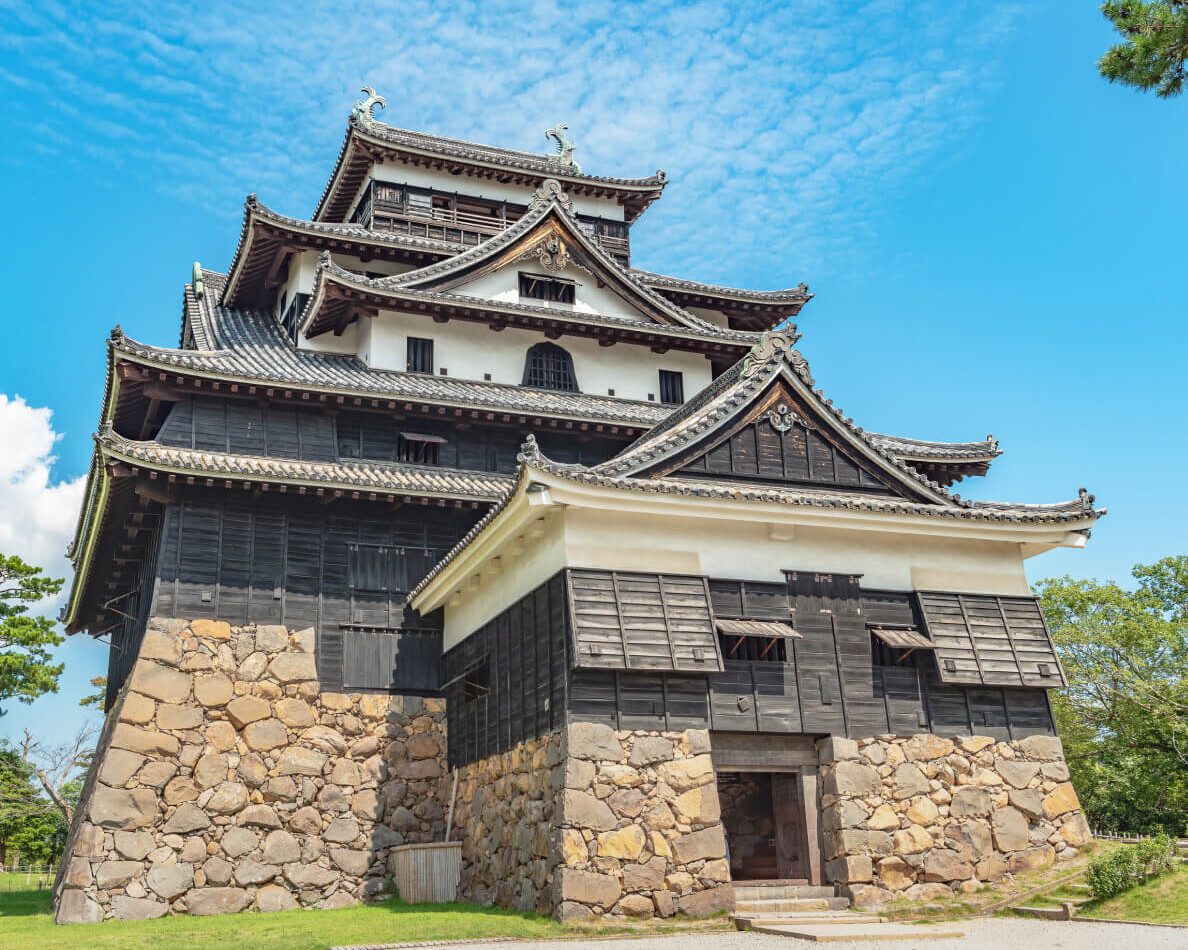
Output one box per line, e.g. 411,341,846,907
95,429,514,501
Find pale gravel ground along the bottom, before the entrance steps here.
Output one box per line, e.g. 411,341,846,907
482,918,1188,950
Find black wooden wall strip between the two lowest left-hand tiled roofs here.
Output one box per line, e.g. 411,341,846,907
157,397,628,473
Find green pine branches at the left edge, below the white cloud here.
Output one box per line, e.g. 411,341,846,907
0,555,63,715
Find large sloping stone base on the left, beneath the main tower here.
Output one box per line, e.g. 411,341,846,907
56,619,450,923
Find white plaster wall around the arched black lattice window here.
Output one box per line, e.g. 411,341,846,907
354,311,710,400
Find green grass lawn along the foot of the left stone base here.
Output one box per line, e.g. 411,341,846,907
0,874,571,950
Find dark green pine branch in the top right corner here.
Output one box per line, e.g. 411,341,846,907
1098,0,1188,99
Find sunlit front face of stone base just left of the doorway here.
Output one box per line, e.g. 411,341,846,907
552,722,734,919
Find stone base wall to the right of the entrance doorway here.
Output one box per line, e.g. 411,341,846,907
817,735,1091,906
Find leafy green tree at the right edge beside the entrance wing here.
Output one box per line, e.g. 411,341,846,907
1037,556,1188,834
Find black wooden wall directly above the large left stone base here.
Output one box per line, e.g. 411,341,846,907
152,490,481,692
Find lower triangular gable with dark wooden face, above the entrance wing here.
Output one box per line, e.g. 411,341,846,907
593,328,963,505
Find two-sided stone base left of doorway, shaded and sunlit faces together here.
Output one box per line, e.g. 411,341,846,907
456,722,733,920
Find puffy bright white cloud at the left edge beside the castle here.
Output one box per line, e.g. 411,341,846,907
0,393,86,598
